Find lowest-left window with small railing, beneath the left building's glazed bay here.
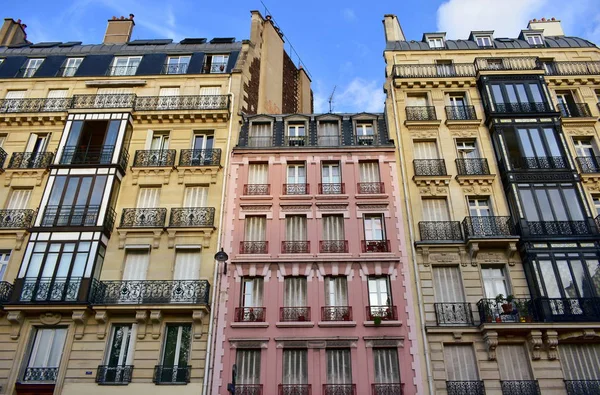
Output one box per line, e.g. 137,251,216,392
23,328,67,382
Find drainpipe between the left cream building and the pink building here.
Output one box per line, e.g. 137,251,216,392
202,75,235,395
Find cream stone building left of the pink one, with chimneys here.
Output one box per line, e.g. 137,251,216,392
0,11,311,394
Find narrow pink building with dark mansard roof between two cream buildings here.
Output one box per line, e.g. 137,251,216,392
212,114,422,395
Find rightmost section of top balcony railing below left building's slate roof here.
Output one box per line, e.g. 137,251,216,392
134,95,229,111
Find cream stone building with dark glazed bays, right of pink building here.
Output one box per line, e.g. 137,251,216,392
384,15,600,395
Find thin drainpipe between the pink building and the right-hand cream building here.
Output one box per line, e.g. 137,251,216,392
390,84,435,395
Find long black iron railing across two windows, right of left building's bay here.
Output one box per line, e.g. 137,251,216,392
90,280,210,306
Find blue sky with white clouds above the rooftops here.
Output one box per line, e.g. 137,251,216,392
1,0,600,112
